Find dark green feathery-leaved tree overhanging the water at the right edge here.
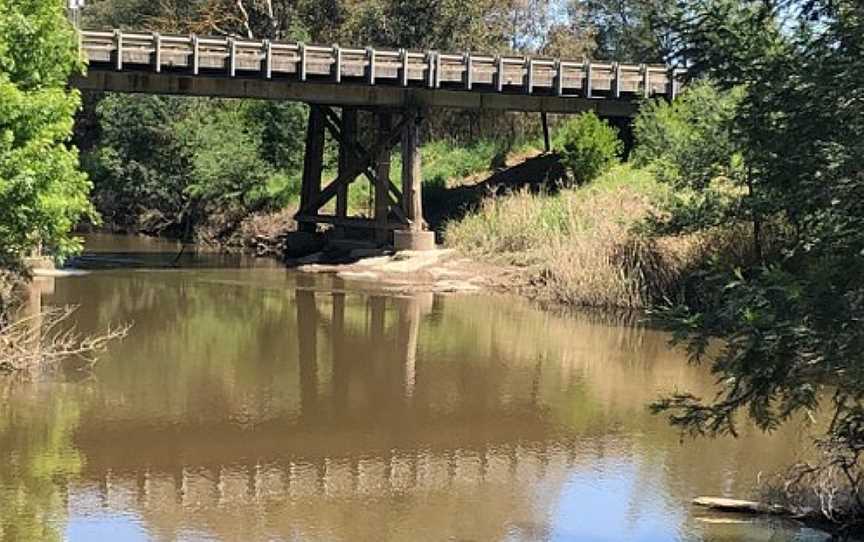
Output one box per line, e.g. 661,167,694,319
655,0,864,521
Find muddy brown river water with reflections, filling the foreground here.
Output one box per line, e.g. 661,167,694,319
0,236,836,541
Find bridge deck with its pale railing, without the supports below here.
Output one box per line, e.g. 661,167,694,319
73,30,681,116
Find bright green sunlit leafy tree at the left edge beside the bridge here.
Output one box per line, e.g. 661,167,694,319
0,0,94,261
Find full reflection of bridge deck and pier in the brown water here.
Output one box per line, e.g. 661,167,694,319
62,283,584,539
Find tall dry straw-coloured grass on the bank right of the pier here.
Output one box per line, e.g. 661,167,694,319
445,165,732,309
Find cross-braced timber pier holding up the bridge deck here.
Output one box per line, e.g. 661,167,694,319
295,105,435,250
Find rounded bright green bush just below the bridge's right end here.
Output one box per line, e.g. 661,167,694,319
555,112,624,184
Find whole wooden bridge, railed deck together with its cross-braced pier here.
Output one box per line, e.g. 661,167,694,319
72,30,683,249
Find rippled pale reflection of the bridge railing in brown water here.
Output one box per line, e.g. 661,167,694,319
87,442,576,509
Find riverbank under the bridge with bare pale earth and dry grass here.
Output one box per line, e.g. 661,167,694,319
211,153,746,310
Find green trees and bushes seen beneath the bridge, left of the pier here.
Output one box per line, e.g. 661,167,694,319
87,96,305,235
